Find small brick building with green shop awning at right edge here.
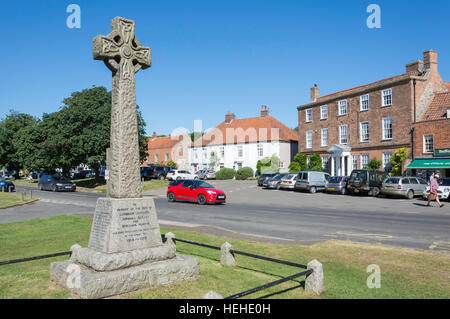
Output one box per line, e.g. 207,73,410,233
408,92,450,177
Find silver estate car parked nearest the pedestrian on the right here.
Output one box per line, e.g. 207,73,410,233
381,176,428,199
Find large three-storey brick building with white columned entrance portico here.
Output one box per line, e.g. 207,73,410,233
297,50,449,175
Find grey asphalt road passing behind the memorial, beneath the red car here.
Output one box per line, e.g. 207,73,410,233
0,181,450,252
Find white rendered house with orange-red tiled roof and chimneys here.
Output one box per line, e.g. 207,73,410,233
188,106,298,172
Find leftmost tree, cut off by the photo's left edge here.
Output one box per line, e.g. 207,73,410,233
0,110,39,175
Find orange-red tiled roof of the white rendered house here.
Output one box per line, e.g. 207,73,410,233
193,115,298,146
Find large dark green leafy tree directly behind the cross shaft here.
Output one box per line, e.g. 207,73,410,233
14,87,147,180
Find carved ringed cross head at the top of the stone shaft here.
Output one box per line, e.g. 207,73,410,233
94,17,152,76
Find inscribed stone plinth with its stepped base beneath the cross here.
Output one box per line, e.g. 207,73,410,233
50,198,200,298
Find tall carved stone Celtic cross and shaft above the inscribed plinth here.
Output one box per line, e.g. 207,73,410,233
93,17,151,198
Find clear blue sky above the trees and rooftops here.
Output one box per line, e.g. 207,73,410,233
0,0,450,135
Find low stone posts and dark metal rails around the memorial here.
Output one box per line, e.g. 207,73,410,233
0,233,324,299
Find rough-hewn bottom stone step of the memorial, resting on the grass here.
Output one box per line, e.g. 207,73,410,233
50,254,200,299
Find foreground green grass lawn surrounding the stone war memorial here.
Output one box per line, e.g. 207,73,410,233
0,215,450,298
